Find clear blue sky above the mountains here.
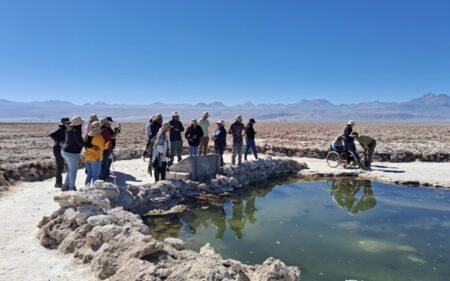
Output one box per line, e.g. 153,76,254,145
0,0,450,104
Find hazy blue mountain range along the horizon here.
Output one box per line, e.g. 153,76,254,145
0,93,450,123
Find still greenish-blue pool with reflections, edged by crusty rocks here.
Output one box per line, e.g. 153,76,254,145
147,180,450,281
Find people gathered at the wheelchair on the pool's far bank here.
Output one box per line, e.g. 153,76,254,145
331,120,377,170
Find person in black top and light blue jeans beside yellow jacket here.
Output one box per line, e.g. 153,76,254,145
61,116,92,191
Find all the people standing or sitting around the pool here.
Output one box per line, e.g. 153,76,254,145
50,112,376,188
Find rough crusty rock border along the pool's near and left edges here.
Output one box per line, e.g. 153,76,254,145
37,159,306,281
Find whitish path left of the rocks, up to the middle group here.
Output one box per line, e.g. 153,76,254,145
0,160,151,281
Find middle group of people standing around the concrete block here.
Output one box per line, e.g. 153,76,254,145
143,112,258,181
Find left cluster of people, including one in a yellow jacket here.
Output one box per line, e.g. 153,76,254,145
50,115,121,191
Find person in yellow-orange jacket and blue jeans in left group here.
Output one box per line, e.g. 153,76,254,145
84,121,109,186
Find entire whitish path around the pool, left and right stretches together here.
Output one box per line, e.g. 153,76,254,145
0,155,450,281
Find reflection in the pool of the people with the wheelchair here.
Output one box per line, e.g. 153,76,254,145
331,180,377,215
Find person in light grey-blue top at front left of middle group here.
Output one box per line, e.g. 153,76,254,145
151,122,170,182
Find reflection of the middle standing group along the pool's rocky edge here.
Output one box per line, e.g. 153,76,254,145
145,179,274,240
